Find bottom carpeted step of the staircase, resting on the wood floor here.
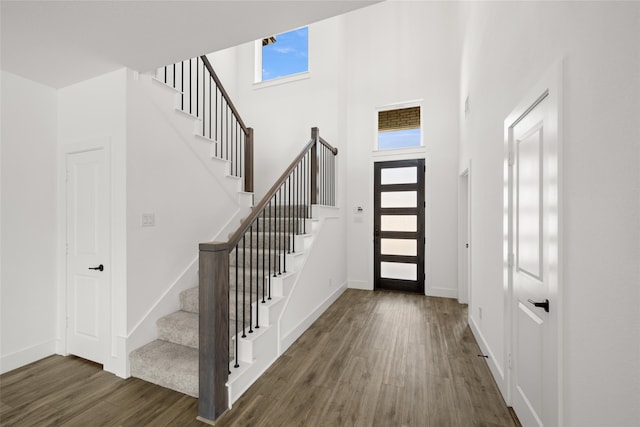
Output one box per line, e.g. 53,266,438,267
130,340,198,397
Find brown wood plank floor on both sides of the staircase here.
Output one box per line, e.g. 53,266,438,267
0,290,518,427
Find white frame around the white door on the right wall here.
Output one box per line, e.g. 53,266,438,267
502,61,564,425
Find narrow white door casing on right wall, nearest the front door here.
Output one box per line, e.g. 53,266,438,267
458,166,471,304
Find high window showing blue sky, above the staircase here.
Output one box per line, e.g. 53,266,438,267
256,27,309,81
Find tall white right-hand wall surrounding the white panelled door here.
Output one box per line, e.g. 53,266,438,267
459,2,640,426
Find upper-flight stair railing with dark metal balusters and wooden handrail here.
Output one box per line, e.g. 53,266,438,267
158,55,253,193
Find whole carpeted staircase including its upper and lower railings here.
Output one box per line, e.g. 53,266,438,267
129,56,339,421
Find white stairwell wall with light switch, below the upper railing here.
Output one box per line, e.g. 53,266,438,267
126,72,242,358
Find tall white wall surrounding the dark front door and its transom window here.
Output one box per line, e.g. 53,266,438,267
343,2,459,297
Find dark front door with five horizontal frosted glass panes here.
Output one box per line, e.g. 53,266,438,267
374,159,425,294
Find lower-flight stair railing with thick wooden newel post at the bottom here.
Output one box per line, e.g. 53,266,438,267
198,128,338,421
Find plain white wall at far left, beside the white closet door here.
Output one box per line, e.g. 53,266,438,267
0,71,57,373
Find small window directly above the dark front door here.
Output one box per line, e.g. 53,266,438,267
378,106,422,150
